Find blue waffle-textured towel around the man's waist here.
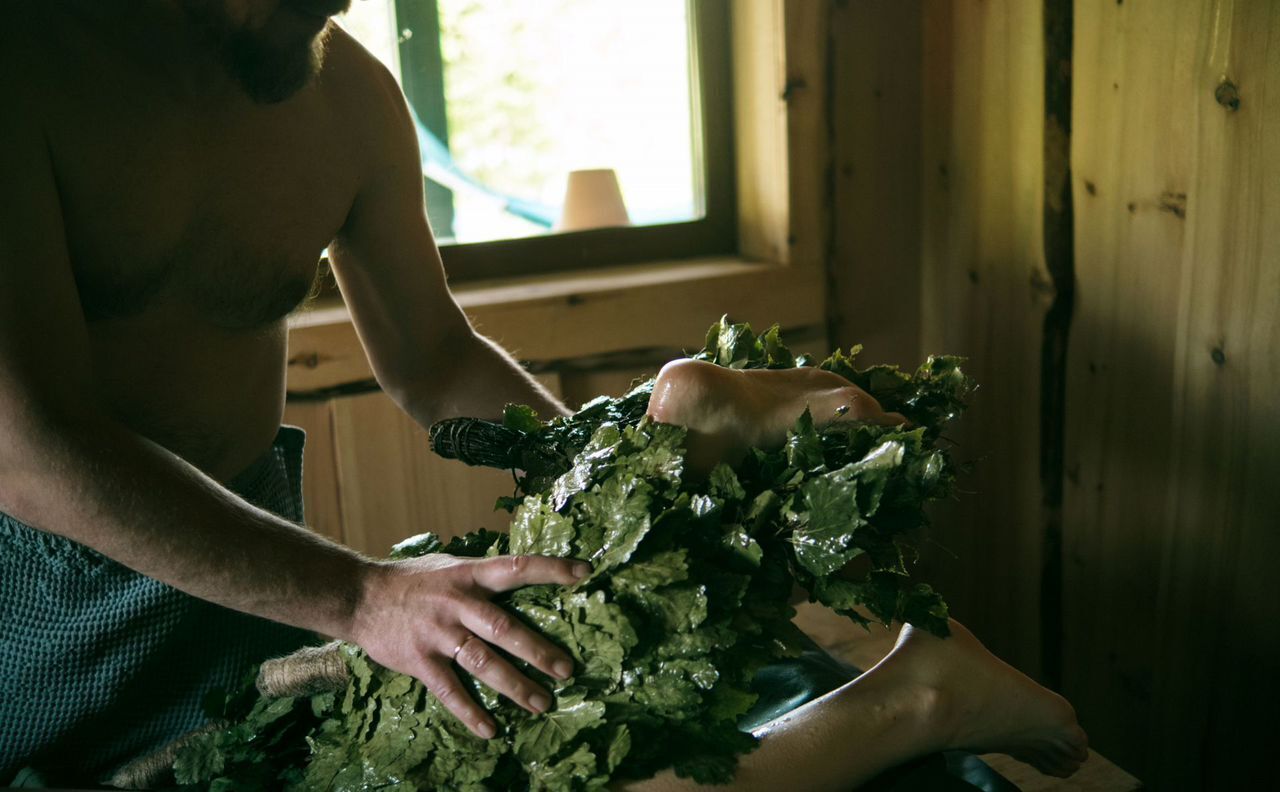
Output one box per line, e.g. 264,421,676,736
0,426,314,784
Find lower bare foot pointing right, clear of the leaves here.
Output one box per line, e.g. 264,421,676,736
876,621,1089,778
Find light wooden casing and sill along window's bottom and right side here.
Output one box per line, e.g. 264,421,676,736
288,0,832,397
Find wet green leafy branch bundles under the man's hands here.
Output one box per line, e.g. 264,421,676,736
167,320,972,791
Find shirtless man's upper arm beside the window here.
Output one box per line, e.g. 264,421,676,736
330,35,471,388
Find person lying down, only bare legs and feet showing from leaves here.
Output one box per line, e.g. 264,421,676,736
629,361,1088,792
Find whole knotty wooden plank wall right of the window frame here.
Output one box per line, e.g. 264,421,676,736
829,0,1280,789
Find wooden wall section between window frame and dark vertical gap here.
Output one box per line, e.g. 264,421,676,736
832,0,1052,674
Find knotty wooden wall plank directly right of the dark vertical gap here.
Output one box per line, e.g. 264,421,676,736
1064,3,1199,772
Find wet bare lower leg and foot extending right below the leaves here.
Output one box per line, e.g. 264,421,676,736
616,622,1088,792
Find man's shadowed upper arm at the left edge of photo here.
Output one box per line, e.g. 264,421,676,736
0,64,92,445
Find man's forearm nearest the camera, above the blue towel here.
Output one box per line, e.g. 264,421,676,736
0,420,372,638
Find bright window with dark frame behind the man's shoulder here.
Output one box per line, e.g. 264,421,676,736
338,0,736,280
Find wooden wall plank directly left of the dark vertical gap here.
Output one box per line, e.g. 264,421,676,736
920,0,1052,677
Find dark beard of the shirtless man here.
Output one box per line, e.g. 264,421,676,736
183,0,347,104
